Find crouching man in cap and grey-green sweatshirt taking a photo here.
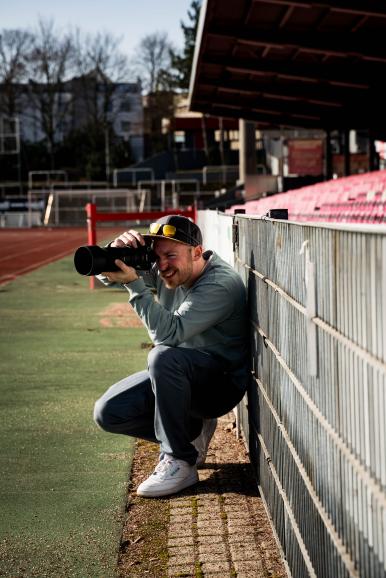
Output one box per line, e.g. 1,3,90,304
94,215,249,497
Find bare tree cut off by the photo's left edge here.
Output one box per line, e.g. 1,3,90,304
0,29,32,117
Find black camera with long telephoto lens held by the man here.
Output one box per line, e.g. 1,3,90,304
74,245,156,276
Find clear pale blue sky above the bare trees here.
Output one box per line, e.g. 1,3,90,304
0,0,191,57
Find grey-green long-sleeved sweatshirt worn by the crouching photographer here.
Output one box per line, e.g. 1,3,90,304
124,251,248,385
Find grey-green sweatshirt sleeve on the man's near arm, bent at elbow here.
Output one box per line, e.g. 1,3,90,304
126,279,234,347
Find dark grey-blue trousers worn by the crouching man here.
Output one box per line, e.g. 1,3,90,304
94,345,245,464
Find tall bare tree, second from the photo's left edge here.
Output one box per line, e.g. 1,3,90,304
29,20,73,168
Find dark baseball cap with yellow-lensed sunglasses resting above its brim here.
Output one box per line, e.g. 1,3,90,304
143,215,202,247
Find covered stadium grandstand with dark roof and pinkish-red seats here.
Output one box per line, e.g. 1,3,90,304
190,0,386,222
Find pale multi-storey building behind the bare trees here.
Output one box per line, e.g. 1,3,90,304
0,73,144,161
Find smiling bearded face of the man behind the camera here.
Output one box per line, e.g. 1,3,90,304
154,239,193,289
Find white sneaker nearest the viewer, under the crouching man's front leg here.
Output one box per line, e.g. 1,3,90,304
137,454,198,498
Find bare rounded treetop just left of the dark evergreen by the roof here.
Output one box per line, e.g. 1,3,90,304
134,32,173,93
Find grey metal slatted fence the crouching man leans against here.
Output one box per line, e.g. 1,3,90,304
199,210,386,578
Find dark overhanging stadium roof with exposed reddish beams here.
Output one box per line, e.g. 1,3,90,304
189,0,386,140
